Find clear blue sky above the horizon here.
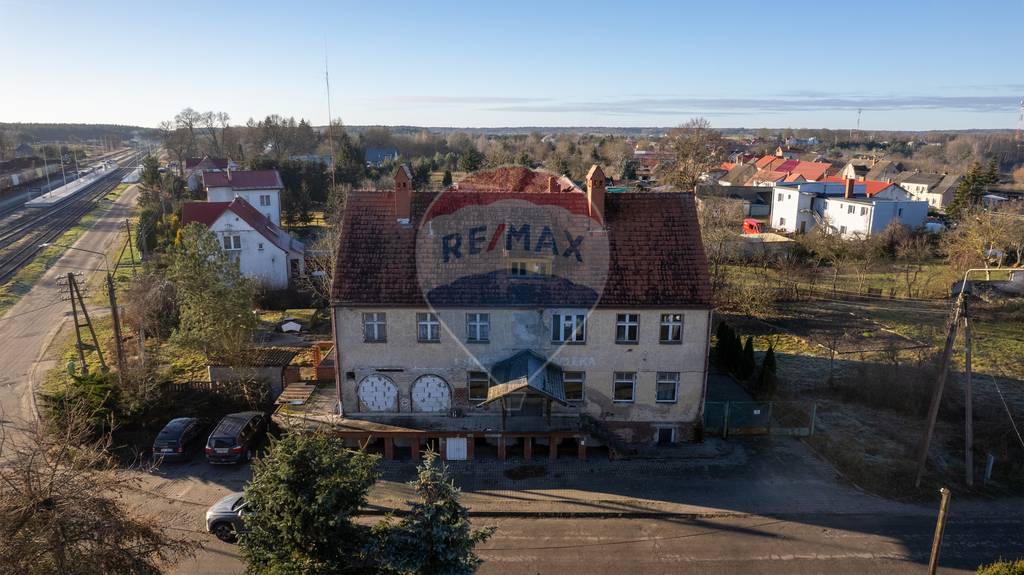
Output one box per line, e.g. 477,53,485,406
0,0,1024,130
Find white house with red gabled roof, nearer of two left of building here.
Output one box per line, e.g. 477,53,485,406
181,196,306,290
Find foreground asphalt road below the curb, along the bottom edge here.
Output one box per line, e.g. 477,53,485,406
153,509,1024,575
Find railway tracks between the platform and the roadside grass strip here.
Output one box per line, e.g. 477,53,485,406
0,168,132,284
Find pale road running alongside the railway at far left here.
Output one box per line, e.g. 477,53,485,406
0,183,138,426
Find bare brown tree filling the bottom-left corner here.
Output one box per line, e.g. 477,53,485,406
0,401,202,575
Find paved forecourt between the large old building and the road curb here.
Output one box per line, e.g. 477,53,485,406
130,437,1024,519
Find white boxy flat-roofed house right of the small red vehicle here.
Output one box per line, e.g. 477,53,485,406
771,179,928,237
